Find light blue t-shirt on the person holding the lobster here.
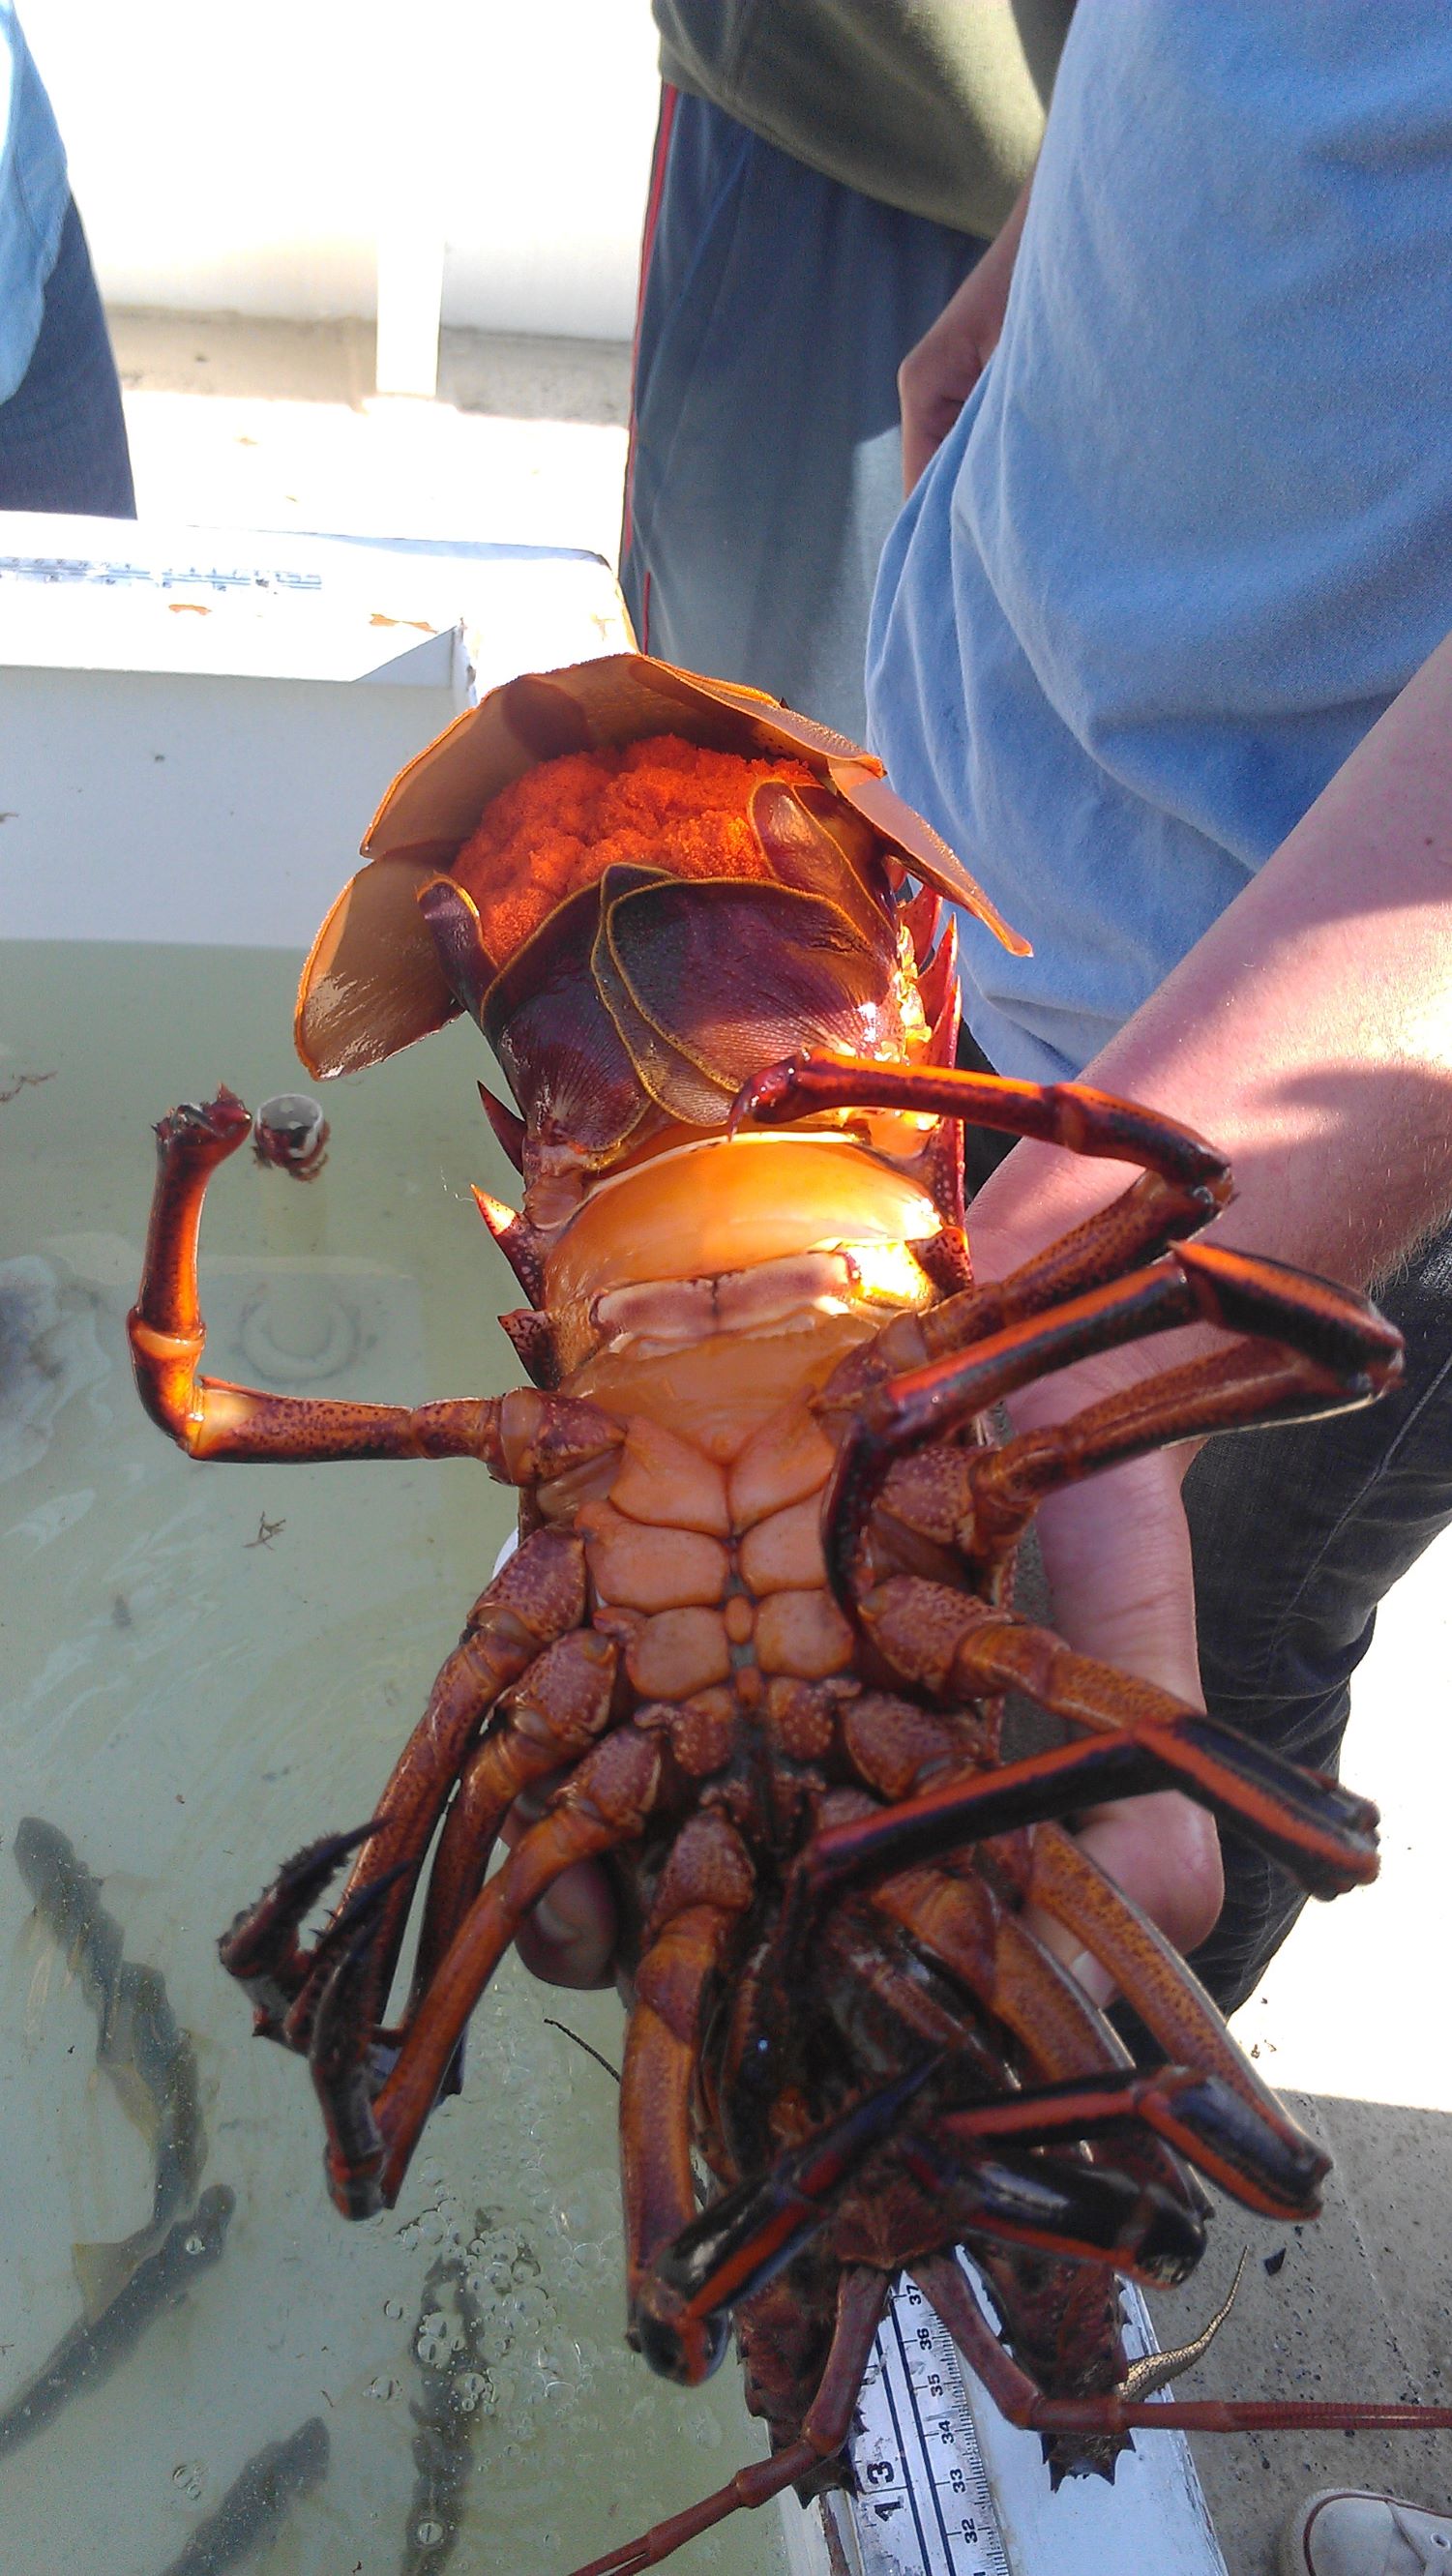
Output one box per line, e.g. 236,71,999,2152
868,0,1452,1080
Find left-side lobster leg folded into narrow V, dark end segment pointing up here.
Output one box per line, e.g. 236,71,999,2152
309,1710,662,2218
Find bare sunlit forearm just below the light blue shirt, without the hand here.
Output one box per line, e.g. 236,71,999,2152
976,638,1452,1308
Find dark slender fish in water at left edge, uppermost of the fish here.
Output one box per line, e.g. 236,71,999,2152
15,1816,206,2321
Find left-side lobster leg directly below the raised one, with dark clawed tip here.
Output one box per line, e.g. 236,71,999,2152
219,1530,584,2048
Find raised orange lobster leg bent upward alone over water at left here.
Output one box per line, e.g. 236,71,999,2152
126,1089,623,1484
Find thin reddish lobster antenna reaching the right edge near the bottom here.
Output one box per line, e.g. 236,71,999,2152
914,2257,1452,2435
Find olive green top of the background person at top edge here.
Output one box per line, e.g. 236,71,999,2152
651,0,1074,234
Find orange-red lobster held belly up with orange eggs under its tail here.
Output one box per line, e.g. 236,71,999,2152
132,654,1452,2576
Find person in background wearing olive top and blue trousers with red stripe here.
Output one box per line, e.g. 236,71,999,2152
620,0,1071,739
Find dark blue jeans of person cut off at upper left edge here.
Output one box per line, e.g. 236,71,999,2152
0,198,136,518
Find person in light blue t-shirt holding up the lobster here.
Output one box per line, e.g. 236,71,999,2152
871,0,1452,2009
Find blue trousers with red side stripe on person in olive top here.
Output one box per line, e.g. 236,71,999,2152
620,90,984,742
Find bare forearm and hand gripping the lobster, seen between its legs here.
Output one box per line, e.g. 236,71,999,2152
947,641,1452,1945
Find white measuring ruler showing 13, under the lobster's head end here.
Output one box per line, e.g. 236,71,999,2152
783,2265,1226,2576
